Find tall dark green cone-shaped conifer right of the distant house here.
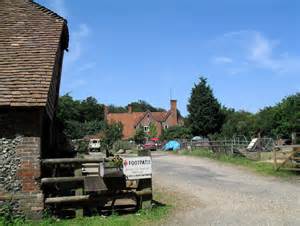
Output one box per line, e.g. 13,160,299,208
188,77,224,136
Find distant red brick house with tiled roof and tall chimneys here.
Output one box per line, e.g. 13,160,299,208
105,100,183,139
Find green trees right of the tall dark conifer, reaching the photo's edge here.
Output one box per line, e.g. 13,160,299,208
218,93,300,139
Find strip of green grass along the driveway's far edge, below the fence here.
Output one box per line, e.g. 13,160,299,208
179,149,299,178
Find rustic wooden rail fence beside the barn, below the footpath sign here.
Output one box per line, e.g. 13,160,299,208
41,154,152,216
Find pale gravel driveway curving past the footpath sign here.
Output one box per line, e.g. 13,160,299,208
153,153,300,225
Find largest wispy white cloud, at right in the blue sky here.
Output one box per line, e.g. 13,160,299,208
214,30,300,74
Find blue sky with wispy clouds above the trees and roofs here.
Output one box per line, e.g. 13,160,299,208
36,0,300,115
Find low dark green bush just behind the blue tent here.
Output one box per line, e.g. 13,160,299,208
160,126,192,140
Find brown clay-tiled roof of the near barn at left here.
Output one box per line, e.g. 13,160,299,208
0,0,69,106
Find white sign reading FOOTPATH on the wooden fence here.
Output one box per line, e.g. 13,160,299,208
123,156,152,180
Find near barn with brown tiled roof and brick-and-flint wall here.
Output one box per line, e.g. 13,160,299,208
0,0,69,218
